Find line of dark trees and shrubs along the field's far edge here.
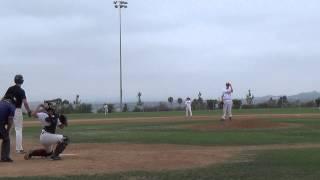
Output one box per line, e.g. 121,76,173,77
49,90,320,114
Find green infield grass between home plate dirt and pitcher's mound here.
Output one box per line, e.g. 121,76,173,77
24,117,320,146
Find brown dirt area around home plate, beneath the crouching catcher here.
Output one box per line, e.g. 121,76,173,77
0,144,320,176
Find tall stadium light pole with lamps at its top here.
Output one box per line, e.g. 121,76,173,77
113,0,128,112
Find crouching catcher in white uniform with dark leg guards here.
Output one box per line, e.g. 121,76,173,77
24,103,69,160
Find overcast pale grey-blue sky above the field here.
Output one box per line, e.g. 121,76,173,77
0,0,320,102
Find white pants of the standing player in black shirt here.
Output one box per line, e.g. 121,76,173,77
13,108,23,151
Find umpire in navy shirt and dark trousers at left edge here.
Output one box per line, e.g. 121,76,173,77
0,94,15,162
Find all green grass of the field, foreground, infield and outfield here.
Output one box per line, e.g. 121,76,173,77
9,109,320,180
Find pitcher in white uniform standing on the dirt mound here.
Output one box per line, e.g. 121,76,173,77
221,82,233,120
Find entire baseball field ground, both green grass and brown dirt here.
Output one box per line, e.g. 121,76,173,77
0,108,320,180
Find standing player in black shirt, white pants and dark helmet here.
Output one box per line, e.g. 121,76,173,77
5,74,31,154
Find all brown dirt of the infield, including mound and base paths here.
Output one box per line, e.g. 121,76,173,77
0,115,320,177
